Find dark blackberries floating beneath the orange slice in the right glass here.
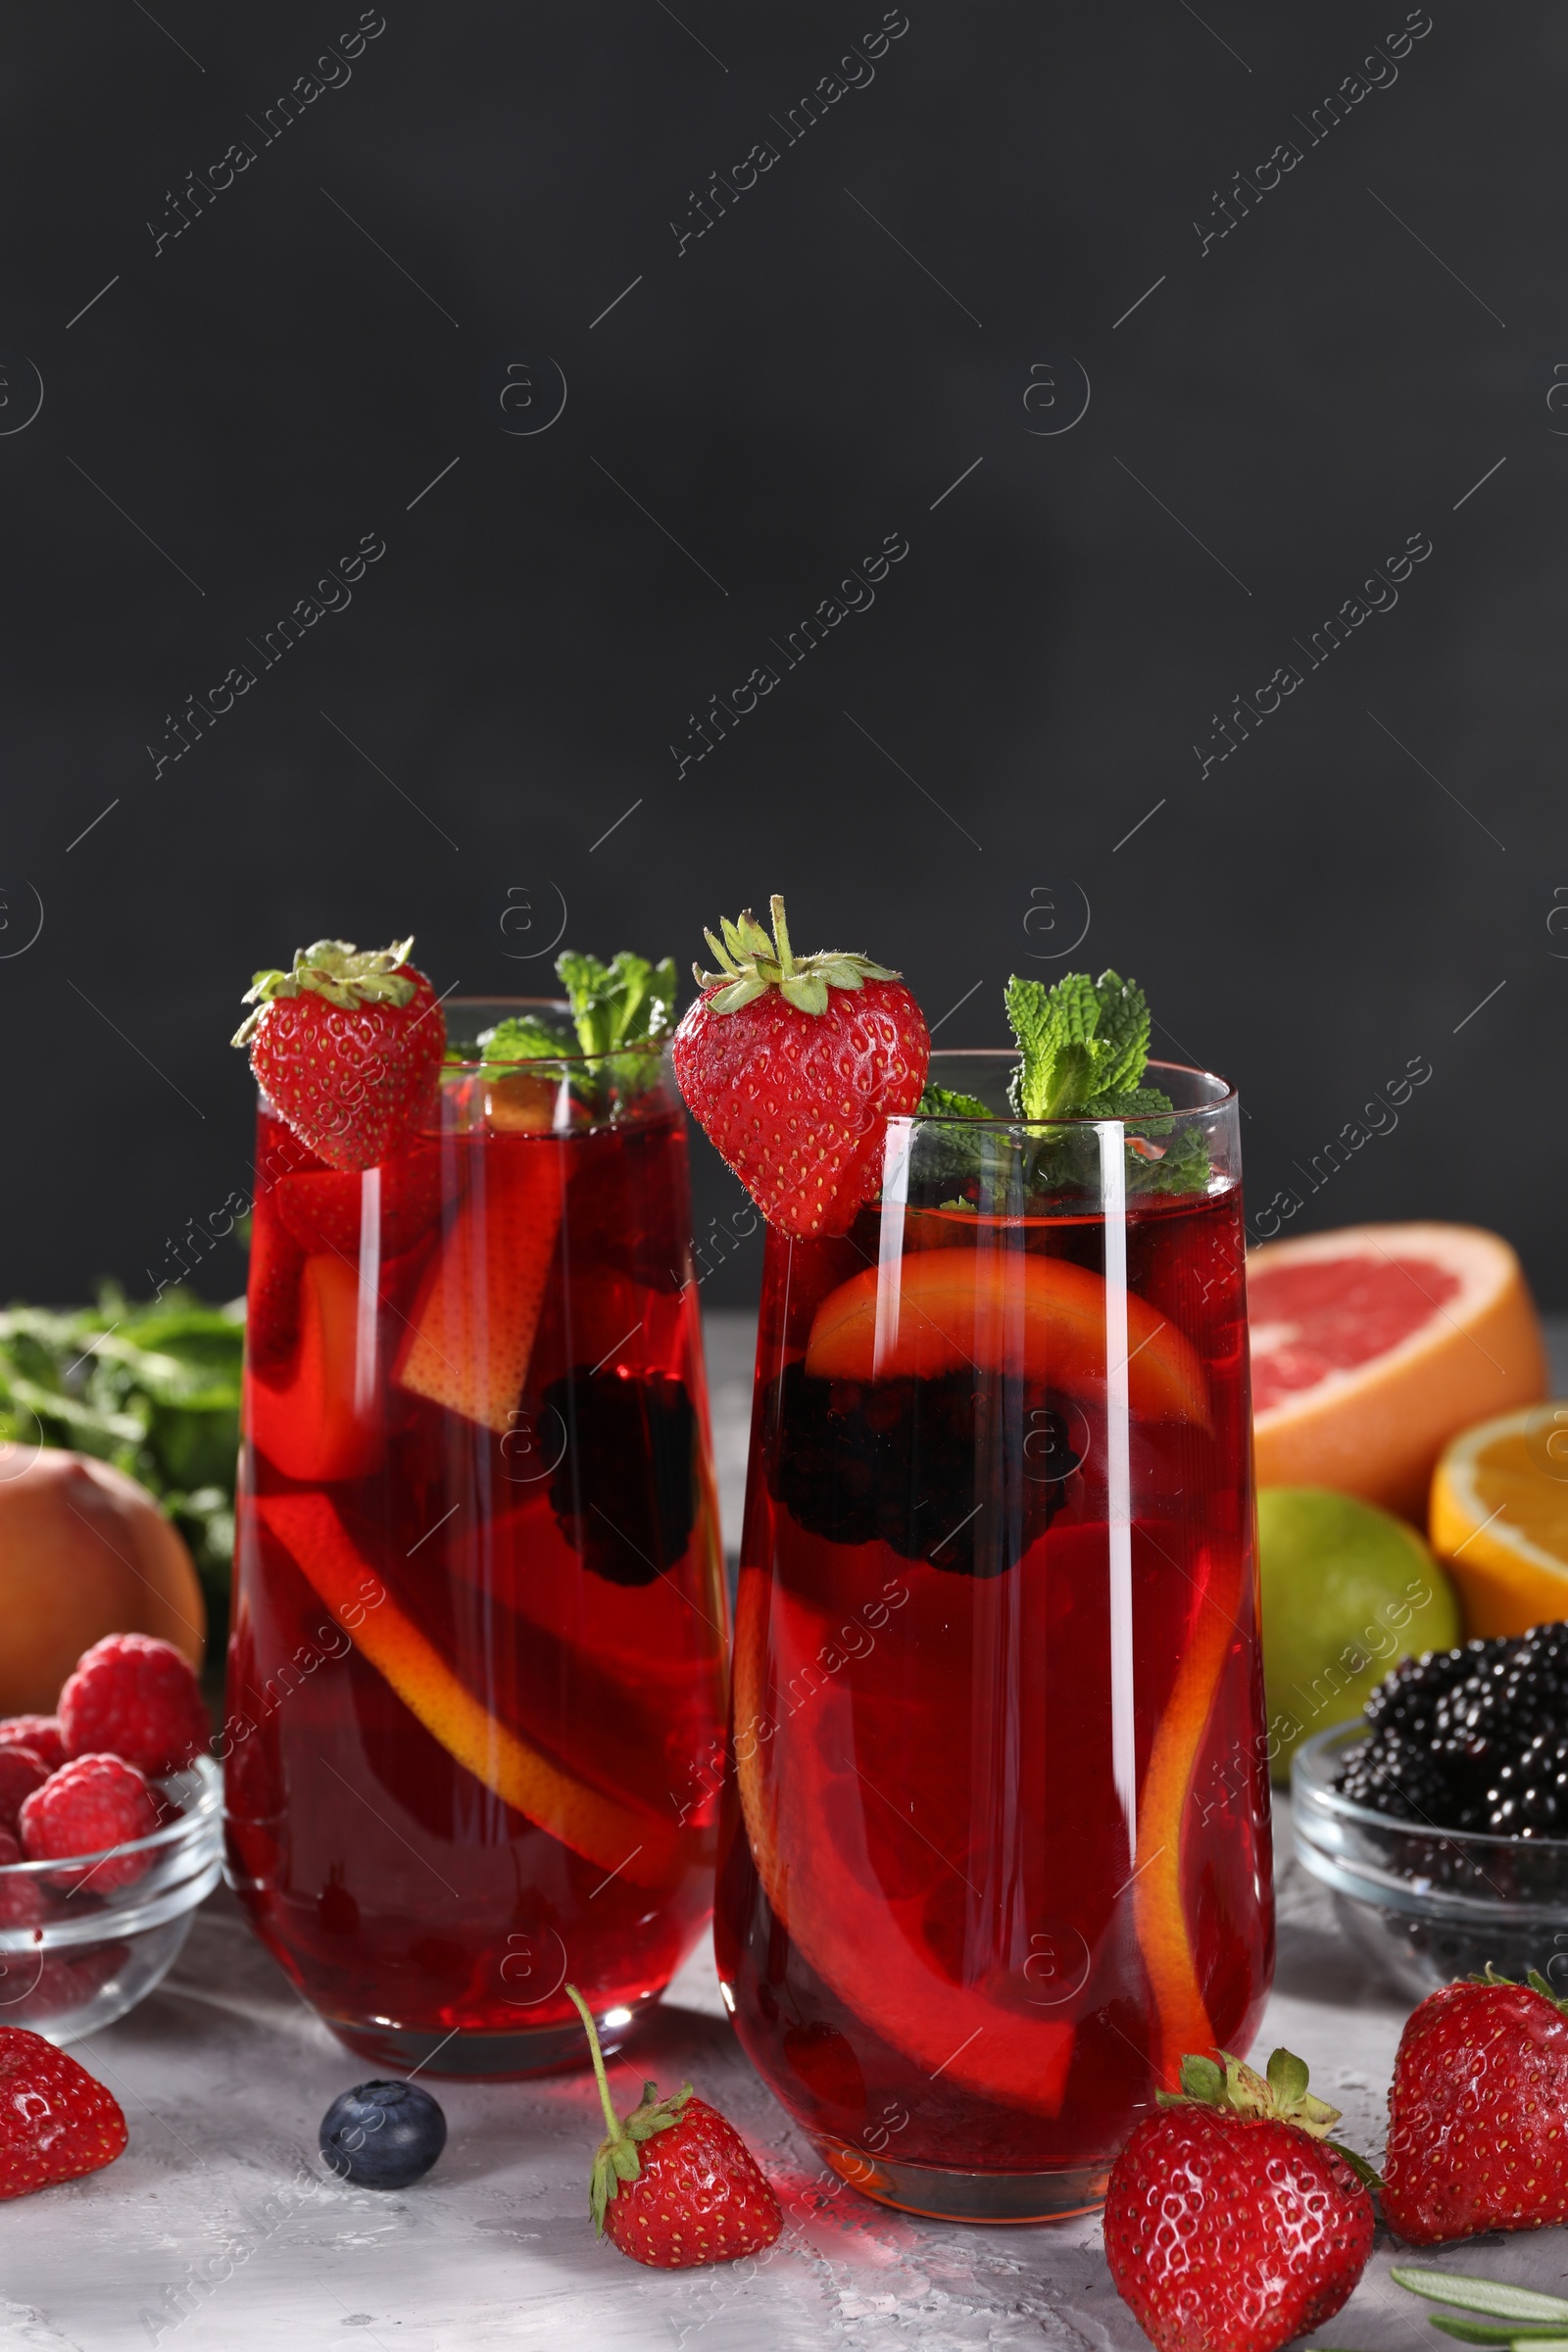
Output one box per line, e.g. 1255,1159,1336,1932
766,1364,1079,1576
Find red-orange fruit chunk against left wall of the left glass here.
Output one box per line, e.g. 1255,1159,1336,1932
247,1251,385,1484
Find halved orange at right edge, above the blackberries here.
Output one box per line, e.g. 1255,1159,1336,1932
1432,1399,1568,1637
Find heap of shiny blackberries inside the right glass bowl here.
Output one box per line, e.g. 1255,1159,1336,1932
1338,1623,1568,1837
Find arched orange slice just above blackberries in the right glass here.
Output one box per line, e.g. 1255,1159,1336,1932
807,1249,1208,1428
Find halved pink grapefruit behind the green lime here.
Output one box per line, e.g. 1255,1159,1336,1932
1246,1225,1546,1522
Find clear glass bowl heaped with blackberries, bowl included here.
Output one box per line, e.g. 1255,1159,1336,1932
1291,1623,1568,1999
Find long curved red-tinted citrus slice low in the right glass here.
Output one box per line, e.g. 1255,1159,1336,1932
736,1569,1074,2115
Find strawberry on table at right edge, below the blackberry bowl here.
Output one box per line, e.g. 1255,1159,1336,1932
1382,1971,1568,2246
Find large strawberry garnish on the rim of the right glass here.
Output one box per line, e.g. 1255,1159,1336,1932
674,896,931,1237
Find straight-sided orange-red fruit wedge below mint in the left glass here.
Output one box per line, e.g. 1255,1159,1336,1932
397,1136,566,1430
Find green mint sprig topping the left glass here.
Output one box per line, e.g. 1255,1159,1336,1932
447,948,677,1117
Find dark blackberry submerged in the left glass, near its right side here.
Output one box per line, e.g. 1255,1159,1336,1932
543,1371,696,1586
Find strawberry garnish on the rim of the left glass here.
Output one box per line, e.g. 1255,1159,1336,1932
232,939,447,1169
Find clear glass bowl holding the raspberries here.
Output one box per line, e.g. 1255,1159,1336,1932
0,1757,223,2041
